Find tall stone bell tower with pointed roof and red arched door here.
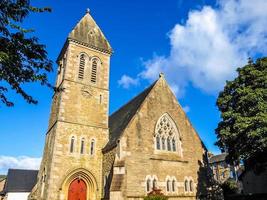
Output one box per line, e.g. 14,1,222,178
30,11,112,200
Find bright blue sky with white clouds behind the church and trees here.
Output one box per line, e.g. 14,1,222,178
0,0,267,173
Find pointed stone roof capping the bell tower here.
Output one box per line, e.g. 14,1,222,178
68,11,112,53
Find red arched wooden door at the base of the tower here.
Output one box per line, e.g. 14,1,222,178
68,179,87,200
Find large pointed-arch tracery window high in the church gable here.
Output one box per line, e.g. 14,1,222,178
155,113,182,156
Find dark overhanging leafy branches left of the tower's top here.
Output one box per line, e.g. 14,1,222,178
0,0,52,106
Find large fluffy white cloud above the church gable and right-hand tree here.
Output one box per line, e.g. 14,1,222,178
122,0,267,97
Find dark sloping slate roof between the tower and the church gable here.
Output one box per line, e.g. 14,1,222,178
103,81,156,151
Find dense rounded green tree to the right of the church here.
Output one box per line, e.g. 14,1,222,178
216,57,267,167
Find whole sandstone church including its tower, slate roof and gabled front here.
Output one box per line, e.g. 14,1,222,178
29,12,209,200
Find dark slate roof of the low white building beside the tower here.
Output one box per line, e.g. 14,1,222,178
4,169,38,193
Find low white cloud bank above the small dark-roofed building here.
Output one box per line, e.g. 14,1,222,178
0,156,41,173
